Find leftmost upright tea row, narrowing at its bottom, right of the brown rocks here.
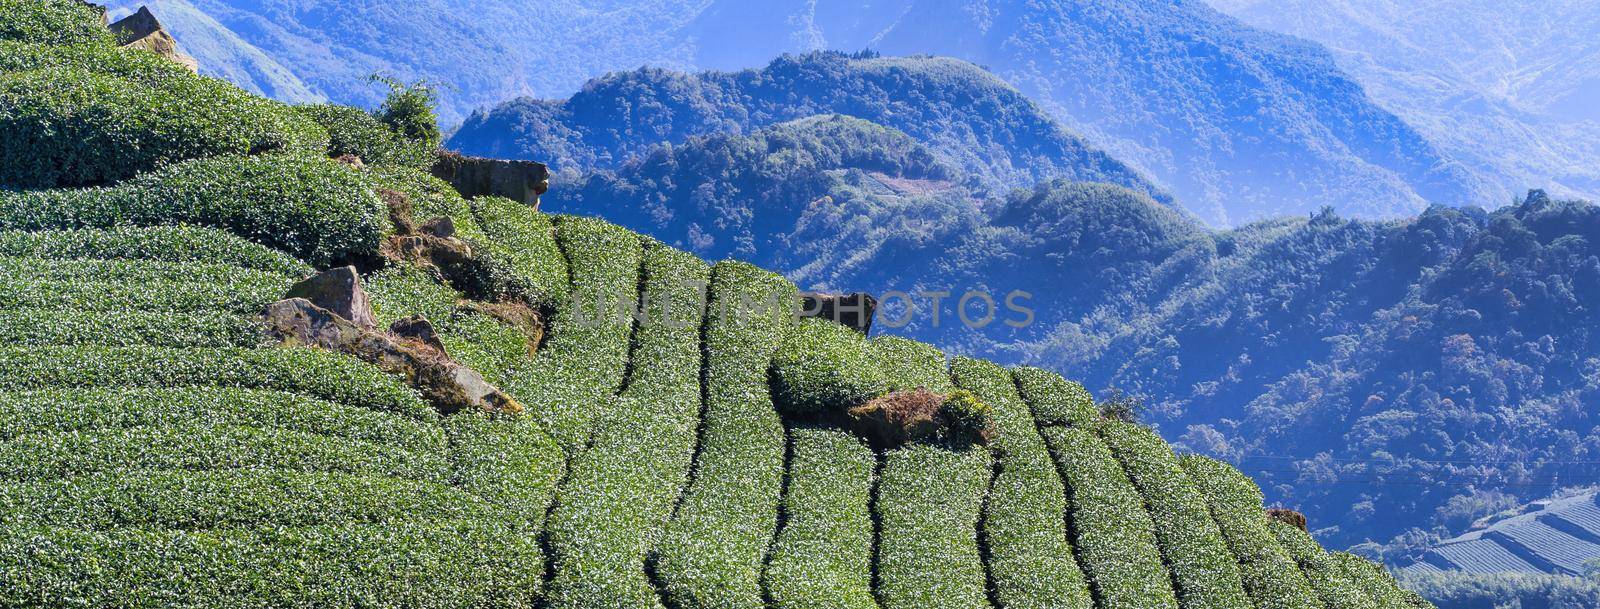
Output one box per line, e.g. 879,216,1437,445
506,217,642,454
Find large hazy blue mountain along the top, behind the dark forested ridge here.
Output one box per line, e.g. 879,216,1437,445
112,0,1497,225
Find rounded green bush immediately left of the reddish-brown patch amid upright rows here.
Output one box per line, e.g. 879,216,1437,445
773,316,890,414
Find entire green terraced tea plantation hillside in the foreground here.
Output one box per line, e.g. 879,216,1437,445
0,0,1426,609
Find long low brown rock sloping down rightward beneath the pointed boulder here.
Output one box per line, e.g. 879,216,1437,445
261,297,523,414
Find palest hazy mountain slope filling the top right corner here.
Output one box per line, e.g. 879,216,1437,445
1213,0,1600,214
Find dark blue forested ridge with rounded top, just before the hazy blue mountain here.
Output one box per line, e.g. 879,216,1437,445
446,53,1171,201
